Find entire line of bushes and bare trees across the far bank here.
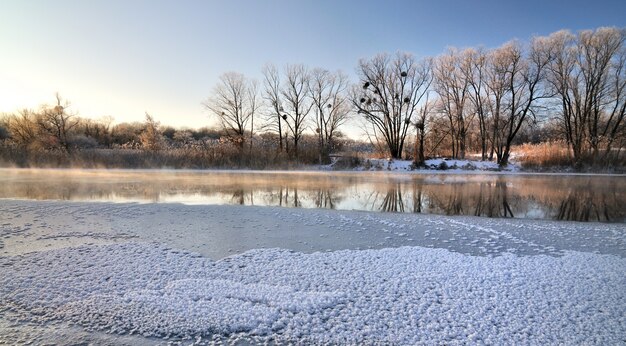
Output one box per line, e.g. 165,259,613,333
0,28,626,168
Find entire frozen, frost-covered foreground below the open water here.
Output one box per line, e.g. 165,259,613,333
0,200,626,345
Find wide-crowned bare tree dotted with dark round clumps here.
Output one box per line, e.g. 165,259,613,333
351,53,431,158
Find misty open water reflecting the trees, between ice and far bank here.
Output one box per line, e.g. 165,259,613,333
0,169,626,223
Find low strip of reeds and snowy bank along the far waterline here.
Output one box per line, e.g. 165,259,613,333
0,146,626,174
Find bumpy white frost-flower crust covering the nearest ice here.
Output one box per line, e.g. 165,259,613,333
0,243,626,344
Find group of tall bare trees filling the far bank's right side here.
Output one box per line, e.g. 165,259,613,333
351,28,626,167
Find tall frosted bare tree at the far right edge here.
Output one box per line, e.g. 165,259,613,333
544,28,626,165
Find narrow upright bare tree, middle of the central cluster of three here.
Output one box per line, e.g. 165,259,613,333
281,65,313,159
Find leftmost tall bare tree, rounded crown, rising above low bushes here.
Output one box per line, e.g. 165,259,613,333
203,72,258,148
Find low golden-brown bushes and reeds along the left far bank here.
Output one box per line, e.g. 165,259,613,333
0,95,360,168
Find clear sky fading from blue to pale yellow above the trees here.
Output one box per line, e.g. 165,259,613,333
0,0,626,128
